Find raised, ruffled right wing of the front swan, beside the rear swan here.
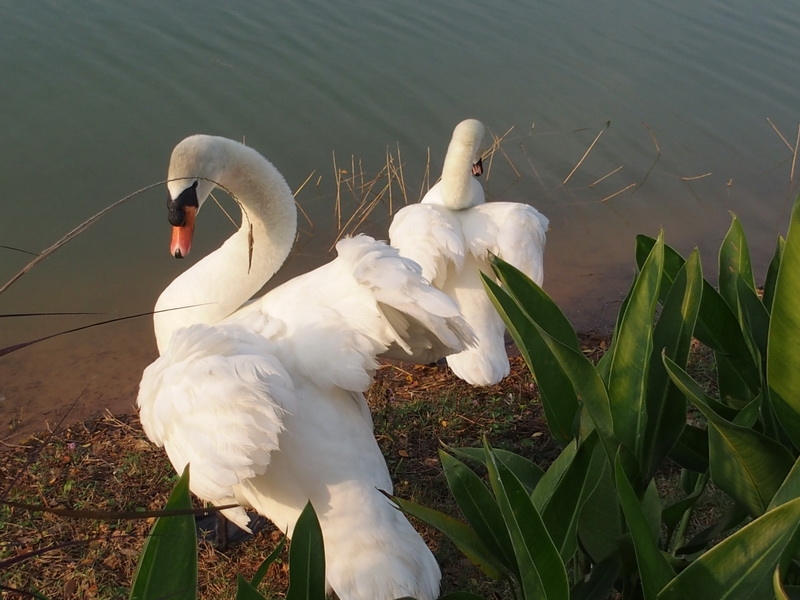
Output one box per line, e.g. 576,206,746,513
241,235,473,376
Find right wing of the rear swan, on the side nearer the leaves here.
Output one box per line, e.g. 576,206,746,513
459,202,549,285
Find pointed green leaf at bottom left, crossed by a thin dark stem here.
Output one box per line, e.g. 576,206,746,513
130,465,197,600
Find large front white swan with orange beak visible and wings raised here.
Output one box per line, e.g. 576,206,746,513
138,136,472,600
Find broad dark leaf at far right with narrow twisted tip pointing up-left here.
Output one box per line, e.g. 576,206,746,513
664,357,794,516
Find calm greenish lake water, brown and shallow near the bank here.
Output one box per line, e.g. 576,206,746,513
0,0,800,440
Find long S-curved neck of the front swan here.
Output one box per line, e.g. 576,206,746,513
153,136,297,353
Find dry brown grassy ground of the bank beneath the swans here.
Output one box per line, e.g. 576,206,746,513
0,349,560,600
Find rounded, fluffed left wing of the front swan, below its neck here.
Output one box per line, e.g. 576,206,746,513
137,325,294,529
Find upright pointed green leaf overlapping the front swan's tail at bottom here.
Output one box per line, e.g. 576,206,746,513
286,502,327,600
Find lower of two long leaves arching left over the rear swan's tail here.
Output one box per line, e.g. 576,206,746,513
481,274,578,444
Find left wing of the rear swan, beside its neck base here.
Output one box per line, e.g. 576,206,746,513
389,200,466,289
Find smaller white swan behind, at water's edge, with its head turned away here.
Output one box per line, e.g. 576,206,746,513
389,119,549,385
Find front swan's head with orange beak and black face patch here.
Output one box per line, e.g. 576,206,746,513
167,135,228,258
